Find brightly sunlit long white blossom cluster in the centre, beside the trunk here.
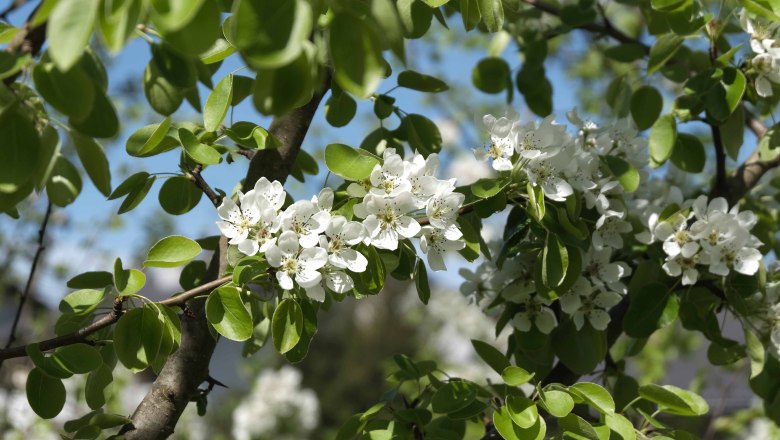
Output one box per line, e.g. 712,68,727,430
217,149,465,301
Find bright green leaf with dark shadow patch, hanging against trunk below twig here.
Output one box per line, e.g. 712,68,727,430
206,286,254,341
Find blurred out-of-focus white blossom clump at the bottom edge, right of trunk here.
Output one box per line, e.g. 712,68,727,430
232,365,320,440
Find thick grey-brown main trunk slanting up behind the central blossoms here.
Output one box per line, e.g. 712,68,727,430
123,73,330,440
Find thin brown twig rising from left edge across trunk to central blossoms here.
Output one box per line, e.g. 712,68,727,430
0,276,233,362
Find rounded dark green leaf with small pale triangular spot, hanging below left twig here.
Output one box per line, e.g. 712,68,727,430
114,305,164,372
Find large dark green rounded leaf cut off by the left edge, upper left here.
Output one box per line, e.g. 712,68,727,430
0,112,40,192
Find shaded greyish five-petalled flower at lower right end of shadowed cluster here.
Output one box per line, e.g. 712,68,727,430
560,278,623,330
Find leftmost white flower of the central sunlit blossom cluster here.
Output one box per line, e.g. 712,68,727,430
217,191,260,255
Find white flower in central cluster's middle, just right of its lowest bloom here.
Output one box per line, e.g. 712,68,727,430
320,215,368,272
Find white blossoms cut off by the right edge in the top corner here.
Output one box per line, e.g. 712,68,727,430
739,9,780,98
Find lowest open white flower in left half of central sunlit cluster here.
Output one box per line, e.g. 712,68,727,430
265,231,328,290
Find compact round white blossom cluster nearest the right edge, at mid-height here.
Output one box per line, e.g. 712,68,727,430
652,196,762,285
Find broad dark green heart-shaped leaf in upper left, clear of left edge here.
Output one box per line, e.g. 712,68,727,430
32,63,95,120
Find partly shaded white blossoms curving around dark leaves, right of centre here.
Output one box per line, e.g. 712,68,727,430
470,110,647,333
